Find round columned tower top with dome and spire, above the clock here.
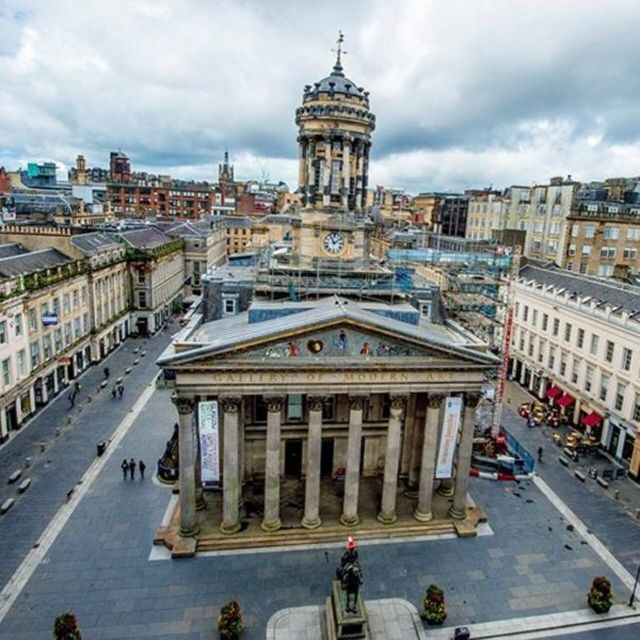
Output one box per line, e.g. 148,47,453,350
296,33,376,211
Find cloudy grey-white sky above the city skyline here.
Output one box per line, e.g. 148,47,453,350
0,0,640,192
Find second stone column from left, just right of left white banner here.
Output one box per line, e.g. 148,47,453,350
220,397,241,534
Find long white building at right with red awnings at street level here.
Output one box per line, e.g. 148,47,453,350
510,265,640,478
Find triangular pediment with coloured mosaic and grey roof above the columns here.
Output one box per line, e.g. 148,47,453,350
159,307,499,368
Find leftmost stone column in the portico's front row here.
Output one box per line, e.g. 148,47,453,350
171,394,198,538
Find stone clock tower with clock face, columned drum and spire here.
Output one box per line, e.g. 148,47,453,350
292,33,376,266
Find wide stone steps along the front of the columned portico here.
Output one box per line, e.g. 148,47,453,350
196,521,457,553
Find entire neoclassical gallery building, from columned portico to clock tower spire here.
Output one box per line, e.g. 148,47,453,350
156,39,499,555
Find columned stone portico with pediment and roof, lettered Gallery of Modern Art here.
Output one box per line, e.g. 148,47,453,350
159,297,497,552
